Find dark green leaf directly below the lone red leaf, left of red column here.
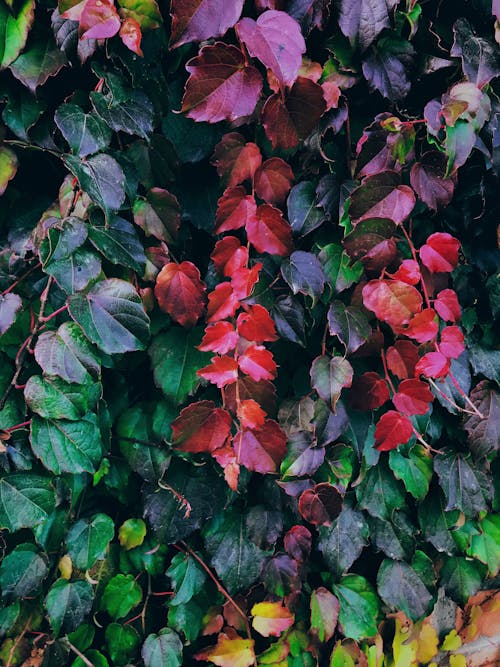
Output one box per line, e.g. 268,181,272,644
149,327,211,405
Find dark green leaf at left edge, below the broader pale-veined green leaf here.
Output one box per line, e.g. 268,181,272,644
0,544,49,601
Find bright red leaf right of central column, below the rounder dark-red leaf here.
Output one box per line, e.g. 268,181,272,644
246,204,293,257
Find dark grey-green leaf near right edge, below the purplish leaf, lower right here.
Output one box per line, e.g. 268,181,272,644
434,452,491,517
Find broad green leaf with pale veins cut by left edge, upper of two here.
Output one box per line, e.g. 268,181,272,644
0,472,56,532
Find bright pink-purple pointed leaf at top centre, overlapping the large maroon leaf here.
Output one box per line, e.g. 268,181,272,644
235,10,306,87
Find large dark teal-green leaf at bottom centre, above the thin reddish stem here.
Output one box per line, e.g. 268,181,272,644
203,509,266,595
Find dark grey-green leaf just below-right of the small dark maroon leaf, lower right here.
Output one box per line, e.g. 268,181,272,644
318,505,369,575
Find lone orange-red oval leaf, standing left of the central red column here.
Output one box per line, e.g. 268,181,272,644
155,262,206,327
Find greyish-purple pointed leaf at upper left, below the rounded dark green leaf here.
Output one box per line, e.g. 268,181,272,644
64,153,125,218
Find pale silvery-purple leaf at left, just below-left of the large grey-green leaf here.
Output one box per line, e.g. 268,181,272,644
35,322,100,384
